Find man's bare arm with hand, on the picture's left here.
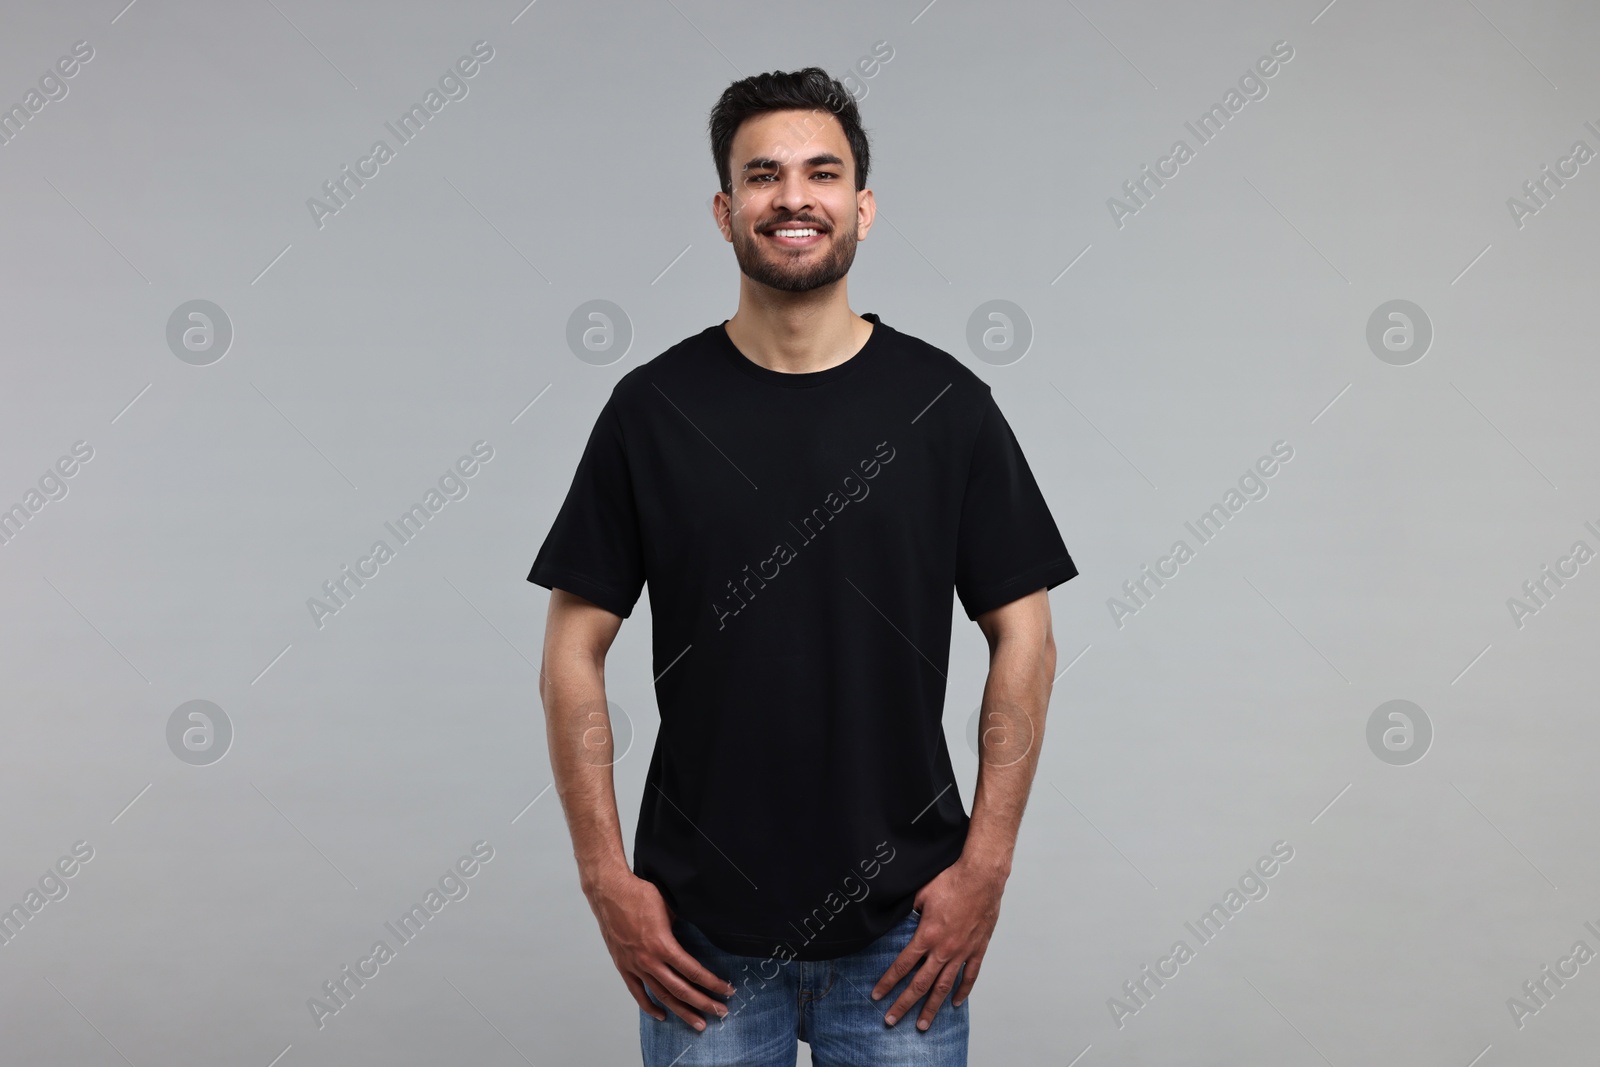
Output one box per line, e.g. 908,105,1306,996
539,589,733,1030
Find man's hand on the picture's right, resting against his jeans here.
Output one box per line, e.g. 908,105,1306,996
872,856,1008,1030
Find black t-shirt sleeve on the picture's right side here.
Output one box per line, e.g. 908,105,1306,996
955,392,1078,619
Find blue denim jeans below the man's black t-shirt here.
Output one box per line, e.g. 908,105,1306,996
638,910,968,1067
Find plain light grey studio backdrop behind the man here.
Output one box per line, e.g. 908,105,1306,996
0,0,1600,1067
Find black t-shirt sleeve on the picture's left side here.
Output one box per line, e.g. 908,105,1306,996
528,394,645,619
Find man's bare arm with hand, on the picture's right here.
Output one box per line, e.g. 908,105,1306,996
872,589,1056,1030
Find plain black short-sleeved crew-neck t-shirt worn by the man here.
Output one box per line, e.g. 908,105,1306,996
528,314,1077,960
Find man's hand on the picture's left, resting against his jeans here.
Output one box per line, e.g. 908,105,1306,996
587,870,734,1030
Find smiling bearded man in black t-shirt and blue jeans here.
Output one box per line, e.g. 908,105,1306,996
528,67,1077,1067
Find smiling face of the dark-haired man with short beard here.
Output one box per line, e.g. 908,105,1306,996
717,109,874,293
